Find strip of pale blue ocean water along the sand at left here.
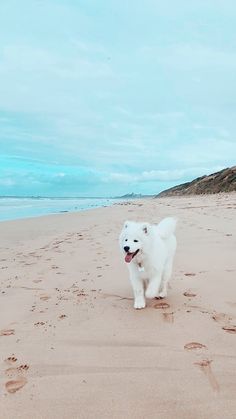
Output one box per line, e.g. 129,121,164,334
0,197,118,221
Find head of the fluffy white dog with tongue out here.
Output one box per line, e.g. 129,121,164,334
120,221,149,263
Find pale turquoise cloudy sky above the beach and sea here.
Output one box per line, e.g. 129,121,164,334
0,0,236,196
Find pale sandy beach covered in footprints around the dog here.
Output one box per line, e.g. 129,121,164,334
0,194,236,419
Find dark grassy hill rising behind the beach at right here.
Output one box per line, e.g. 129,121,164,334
157,166,236,197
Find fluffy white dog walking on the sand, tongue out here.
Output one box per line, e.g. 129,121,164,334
120,217,176,309
